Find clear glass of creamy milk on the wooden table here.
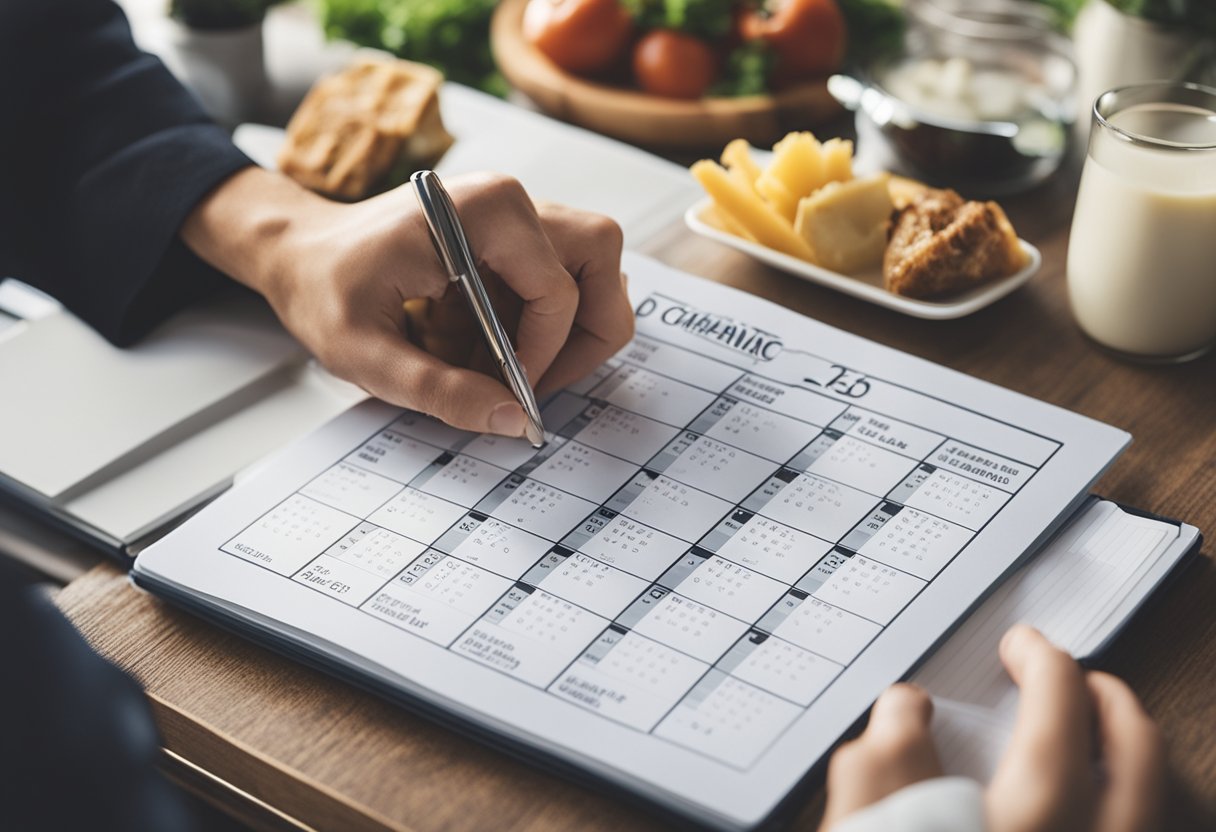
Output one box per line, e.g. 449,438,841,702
1068,83,1216,361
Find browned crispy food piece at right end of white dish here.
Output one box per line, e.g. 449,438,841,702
883,189,1028,298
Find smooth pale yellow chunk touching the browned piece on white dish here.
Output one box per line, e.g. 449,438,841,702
794,174,894,274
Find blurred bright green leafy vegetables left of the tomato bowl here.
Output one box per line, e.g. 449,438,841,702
321,0,507,95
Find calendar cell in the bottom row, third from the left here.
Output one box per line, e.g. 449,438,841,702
361,550,511,645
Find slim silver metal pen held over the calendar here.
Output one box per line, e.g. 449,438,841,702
410,170,545,448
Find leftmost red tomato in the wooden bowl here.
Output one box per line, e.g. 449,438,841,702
524,0,634,73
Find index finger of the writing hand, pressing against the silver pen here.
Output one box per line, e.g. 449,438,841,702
452,175,579,386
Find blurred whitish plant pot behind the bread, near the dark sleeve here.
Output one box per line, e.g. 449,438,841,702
169,21,268,128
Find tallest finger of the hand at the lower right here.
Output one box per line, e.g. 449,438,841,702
989,625,1093,828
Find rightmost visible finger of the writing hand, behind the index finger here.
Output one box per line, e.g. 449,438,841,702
536,204,634,394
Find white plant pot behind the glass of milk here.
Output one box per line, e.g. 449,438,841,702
1073,0,1203,121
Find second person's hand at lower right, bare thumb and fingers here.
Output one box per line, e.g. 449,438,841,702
820,625,1164,832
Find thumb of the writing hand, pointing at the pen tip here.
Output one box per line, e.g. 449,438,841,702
342,327,527,437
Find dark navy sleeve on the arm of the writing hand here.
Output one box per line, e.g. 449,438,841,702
0,0,252,345
